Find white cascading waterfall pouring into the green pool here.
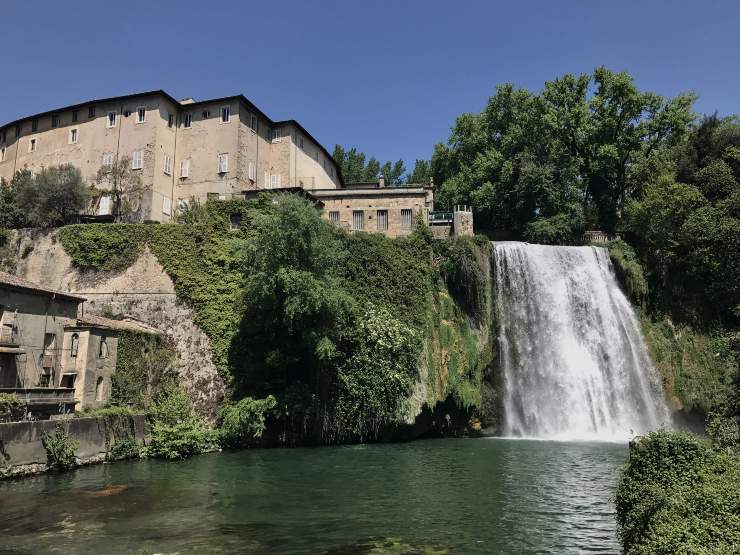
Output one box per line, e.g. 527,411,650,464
495,242,670,441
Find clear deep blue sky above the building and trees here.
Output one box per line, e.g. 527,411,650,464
0,0,740,167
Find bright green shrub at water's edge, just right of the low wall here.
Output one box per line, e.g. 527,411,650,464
144,388,215,459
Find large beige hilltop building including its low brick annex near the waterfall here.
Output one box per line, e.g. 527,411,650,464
0,90,472,237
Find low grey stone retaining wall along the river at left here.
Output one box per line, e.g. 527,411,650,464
0,415,147,477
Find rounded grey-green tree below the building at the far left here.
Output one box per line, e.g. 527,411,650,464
11,164,89,227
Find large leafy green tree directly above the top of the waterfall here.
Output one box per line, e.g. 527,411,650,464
431,67,693,239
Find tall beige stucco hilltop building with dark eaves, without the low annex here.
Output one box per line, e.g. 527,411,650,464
0,91,342,221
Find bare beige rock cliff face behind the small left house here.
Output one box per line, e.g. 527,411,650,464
3,230,226,421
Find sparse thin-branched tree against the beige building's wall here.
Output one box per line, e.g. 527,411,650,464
95,156,151,222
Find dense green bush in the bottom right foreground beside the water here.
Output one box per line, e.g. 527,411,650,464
616,431,740,555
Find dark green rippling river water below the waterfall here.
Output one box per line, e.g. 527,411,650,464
0,439,628,554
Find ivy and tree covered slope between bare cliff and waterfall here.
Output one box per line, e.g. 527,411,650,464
60,195,495,442
